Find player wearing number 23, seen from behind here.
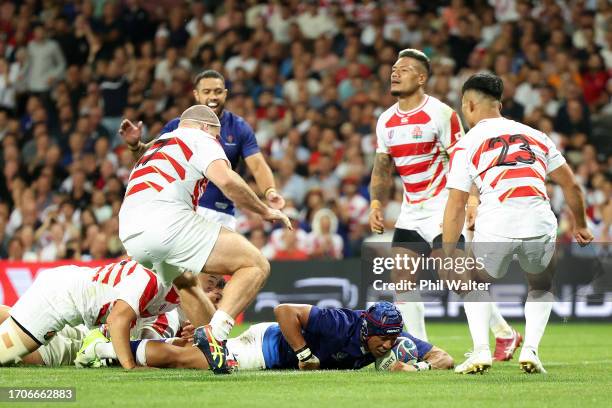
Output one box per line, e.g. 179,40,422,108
443,73,593,373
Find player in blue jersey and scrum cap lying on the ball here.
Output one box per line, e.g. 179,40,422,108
85,302,453,371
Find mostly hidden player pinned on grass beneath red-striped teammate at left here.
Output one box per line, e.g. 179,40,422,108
0,274,225,367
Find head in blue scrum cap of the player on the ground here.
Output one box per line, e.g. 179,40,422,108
362,302,404,358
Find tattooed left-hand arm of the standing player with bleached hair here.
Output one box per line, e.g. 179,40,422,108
369,153,393,234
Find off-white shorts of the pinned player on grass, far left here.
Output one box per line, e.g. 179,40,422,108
38,325,89,367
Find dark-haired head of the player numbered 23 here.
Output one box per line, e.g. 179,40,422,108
461,73,504,127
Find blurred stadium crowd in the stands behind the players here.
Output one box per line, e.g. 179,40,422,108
0,0,612,261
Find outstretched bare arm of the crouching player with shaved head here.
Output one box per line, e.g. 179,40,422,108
206,160,291,228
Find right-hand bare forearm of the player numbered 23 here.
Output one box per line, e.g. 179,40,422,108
549,163,593,246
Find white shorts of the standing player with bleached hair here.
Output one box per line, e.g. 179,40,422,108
395,190,448,243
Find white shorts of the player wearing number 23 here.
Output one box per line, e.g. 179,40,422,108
472,230,557,279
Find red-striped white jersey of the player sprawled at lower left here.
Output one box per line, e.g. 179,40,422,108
92,260,179,325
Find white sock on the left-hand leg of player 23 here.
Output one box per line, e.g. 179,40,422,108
463,292,491,352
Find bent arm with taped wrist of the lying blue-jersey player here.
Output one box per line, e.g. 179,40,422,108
274,304,320,370
